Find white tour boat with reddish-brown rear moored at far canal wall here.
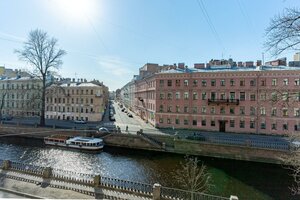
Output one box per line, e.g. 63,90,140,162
44,135,104,150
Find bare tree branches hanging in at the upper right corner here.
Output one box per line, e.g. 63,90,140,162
265,8,300,56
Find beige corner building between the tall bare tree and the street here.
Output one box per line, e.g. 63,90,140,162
45,81,108,121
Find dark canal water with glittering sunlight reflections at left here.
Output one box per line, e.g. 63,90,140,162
0,141,299,200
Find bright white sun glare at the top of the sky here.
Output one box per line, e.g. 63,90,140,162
53,0,96,24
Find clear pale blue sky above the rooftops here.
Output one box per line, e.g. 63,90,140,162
0,0,300,90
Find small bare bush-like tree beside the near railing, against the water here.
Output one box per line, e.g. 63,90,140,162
173,156,212,192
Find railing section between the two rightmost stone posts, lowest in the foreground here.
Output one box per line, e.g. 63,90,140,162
161,187,230,200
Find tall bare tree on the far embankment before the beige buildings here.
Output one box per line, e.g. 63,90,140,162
15,29,66,126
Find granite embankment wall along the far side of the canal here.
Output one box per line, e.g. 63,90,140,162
0,127,290,164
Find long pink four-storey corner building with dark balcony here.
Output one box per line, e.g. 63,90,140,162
135,66,300,135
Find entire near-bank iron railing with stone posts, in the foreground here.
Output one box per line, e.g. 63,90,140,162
0,160,238,200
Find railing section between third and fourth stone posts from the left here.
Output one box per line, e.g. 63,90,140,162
100,176,153,195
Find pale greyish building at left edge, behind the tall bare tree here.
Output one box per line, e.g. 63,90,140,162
0,76,42,117
